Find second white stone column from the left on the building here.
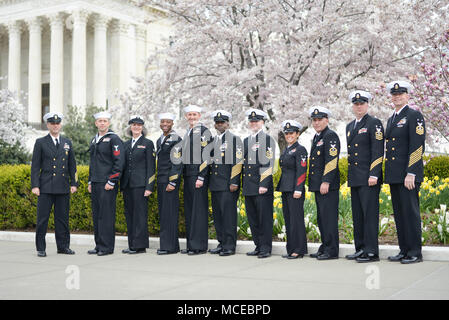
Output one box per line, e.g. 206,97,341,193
26,17,42,123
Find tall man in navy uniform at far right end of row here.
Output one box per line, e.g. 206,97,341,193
385,81,426,264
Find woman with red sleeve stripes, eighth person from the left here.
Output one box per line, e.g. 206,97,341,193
276,120,308,259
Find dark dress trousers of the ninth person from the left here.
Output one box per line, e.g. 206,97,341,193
315,190,339,257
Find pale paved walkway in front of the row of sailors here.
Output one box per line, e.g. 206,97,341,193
0,241,449,300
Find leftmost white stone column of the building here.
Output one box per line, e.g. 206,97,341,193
8,21,22,98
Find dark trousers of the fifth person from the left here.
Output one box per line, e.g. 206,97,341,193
184,176,209,251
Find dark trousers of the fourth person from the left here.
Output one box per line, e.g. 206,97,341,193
157,183,179,252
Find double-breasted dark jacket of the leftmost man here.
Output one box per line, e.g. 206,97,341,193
31,134,78,194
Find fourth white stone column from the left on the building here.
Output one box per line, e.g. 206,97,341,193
72,10,89,107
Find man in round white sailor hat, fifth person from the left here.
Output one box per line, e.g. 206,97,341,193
181,105,213,255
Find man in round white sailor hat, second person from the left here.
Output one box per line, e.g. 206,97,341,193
88,111,125,256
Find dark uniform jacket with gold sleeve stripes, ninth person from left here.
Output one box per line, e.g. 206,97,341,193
309,127,340,191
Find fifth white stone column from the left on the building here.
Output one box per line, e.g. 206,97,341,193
93,15,110,107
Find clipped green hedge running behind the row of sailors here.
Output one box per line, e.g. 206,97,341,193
0,156,449,234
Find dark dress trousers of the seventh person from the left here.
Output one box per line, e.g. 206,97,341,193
245,192,274,253
